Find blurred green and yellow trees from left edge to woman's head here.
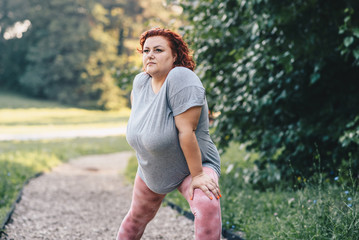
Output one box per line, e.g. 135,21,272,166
0,0,182,110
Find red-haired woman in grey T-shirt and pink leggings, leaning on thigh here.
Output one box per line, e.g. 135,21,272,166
117,28,221,240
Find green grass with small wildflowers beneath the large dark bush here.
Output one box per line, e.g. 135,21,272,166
220,144,359,240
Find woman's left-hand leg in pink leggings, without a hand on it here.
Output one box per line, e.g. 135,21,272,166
117,176,166,240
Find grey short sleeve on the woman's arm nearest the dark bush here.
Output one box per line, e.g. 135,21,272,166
169,86,205,116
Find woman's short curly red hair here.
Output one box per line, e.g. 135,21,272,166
137,28,196,71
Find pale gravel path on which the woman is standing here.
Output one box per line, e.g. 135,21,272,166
0,152,214,240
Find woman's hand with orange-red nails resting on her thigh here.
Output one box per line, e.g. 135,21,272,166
189,172,222,200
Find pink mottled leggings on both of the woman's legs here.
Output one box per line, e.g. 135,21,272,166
117,167,222,240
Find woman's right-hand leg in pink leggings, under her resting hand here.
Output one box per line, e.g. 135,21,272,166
178,167,222,240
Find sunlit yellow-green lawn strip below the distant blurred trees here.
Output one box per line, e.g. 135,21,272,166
0,92,130,134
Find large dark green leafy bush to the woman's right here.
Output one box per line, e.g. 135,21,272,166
181,0,359,181
